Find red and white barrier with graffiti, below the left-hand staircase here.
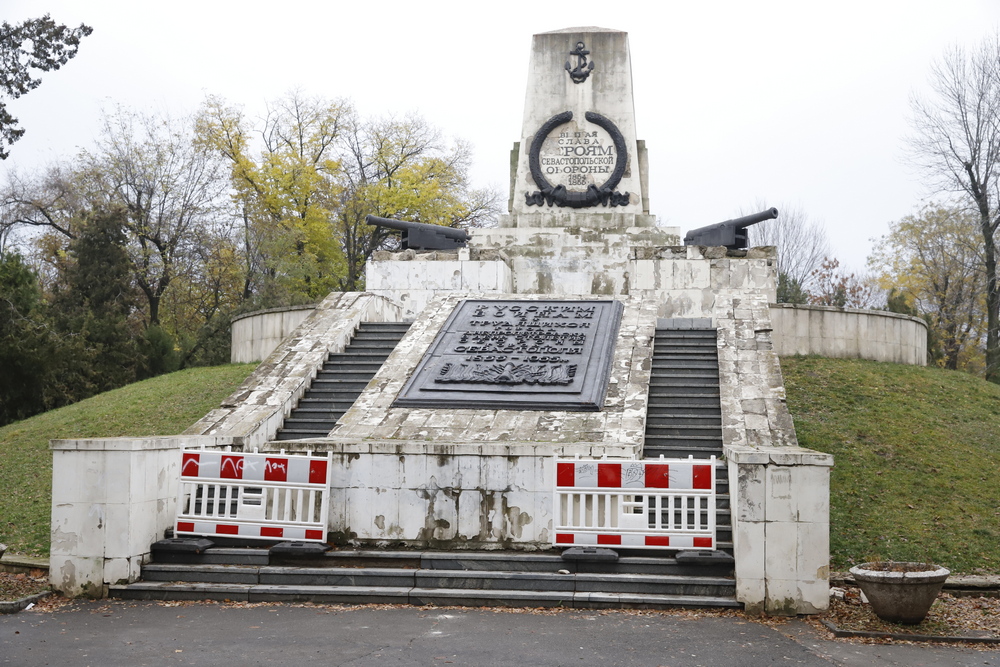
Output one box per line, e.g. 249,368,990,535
174,449,332,542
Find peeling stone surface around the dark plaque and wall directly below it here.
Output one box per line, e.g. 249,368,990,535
268,293,657,549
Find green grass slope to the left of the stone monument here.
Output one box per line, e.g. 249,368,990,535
0,364,255,556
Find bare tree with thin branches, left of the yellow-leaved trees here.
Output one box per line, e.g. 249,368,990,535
0,109,226,325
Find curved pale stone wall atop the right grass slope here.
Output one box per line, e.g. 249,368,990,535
771,303,927,366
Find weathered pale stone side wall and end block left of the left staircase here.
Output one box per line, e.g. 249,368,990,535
49,293,399,597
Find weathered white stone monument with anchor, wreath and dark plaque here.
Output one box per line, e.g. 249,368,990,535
53,28,832,613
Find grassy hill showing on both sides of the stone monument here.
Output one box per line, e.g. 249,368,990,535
0,357,1000,572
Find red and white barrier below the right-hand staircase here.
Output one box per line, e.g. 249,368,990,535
553,457,717,549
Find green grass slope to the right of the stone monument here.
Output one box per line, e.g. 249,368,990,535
781,357,1000,573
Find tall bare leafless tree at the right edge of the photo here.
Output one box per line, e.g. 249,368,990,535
910,35,1000,383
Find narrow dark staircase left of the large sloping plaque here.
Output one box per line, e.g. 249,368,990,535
275,322,410,440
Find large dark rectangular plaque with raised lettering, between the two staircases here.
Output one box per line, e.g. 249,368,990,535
393,299,624,411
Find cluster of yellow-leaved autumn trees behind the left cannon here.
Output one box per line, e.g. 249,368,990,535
198,92,499,305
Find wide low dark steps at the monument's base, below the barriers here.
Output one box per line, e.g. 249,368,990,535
110,547,740,609
